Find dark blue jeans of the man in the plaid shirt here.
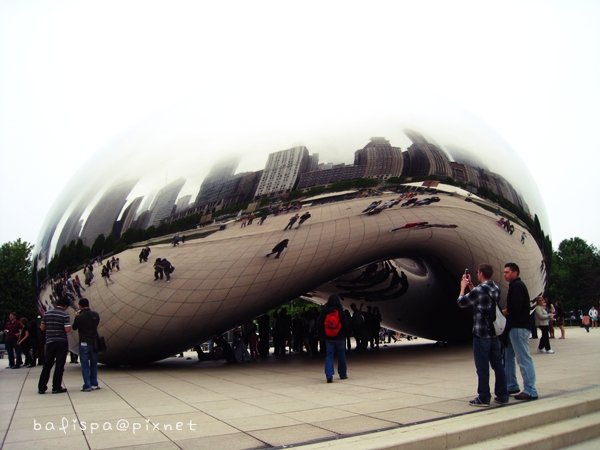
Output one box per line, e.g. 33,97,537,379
473,336,508,403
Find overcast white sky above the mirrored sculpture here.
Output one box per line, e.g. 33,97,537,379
0,0,600,251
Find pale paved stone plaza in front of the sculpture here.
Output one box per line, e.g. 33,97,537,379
0,328,600,449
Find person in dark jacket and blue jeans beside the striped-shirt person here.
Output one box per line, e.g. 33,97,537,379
73,298,100,392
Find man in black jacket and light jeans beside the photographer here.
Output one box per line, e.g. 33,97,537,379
503,262,538,400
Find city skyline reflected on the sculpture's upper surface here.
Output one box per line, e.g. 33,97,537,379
35,116,545,266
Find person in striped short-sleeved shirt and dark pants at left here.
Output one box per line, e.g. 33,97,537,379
38,298,71,394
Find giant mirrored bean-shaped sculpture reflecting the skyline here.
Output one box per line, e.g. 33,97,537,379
36,110,546,364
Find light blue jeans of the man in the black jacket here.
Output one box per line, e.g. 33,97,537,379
504,328,538,397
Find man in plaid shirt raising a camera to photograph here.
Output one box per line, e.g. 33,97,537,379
457,264,508,406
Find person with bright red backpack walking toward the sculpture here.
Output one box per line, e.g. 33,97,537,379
317,294,348,383
